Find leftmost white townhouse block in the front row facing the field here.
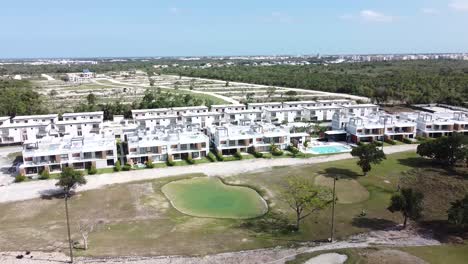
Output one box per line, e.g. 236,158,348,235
20,134,117,176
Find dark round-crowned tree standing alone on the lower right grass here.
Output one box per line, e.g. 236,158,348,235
387,188,424,228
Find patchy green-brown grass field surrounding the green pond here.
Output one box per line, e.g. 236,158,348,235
0,152,467,256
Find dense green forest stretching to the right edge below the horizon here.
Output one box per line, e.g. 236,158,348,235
161,61,468,105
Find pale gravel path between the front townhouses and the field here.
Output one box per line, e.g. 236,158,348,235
0,145,417,203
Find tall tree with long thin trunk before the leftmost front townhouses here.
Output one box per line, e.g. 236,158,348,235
55,167,86,262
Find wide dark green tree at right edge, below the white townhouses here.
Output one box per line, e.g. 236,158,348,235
417,134,468,166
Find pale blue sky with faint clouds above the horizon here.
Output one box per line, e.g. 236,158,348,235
0,0,468,58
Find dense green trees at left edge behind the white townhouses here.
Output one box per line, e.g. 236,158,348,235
0,80,47,116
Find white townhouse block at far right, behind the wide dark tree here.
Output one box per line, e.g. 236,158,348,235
416,112,455,138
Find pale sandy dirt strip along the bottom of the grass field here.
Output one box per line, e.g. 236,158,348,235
0,225,440,264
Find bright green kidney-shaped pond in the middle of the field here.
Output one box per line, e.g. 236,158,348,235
162,177,268,219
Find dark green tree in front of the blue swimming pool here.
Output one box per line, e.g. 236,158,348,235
351,144,386,176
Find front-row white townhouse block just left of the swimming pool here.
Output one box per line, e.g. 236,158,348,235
210,123,290,155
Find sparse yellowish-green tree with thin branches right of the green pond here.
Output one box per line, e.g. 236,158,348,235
281,176,333,230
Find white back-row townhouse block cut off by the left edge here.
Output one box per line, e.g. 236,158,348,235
0,114,58,144
